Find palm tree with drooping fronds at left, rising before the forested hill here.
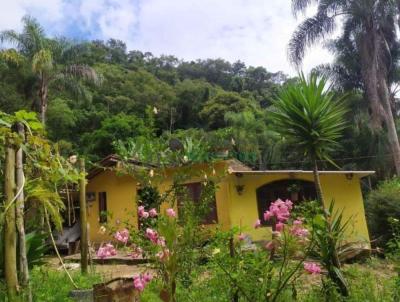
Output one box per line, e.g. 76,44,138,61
0,16,100,124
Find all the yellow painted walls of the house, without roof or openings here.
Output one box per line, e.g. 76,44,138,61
87,164,369,242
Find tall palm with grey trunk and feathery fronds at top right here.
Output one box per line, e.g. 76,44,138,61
289,0,400,175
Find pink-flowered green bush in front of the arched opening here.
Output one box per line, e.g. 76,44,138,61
207,199,321,301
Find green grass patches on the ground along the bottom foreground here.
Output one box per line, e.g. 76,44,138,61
0,259,397,302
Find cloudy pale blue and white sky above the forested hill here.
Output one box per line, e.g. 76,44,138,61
0,0,332,75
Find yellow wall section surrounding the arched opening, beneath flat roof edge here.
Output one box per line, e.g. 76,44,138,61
229,173,369,241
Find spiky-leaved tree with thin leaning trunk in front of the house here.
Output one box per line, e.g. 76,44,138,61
269,74,348,296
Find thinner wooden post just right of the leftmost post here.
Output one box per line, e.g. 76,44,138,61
15,123,32,301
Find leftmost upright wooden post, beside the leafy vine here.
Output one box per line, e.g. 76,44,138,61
4,137,19,302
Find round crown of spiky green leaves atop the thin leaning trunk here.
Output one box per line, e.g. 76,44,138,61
269,74,346,160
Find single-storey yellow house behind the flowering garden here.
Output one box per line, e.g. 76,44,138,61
86,156,374,242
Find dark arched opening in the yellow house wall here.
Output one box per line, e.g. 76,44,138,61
257,179,317,225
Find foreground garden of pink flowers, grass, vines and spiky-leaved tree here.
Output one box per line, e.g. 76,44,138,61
0,75,400,302
